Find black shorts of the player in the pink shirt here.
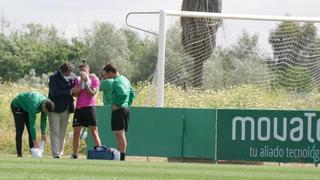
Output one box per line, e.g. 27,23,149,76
72,106,98,127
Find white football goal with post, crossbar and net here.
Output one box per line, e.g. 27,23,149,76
155,10,320,107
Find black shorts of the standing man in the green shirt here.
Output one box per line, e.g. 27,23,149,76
111,108,130,131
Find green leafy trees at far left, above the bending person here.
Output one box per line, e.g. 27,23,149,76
0,23,86,81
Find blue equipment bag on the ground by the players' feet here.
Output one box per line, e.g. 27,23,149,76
87,146,115,160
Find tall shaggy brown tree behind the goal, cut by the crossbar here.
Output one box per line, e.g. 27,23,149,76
181,0,222,87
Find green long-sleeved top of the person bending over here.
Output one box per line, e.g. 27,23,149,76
12,92,49,140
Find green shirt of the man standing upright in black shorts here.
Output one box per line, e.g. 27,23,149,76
112,75,132,107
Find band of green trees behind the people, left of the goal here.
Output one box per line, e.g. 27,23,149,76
0,22,157,82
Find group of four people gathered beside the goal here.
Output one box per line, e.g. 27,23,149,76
11,61,135,160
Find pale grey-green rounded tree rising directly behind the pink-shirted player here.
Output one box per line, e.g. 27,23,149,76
85,22,134,78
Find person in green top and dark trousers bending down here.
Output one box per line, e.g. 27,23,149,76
11,92,55,157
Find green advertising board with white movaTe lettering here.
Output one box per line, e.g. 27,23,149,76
217,109,320,163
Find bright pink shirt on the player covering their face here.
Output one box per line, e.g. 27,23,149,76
75,74,100,109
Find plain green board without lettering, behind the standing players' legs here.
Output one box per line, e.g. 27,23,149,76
86,106,216,160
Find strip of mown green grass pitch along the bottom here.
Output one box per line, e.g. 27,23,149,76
0,156,320,180
